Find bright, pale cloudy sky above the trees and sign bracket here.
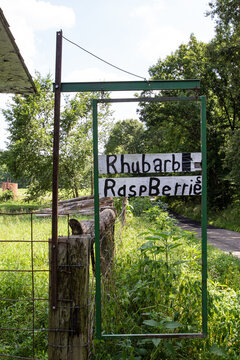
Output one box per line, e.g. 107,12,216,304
0,0,214,149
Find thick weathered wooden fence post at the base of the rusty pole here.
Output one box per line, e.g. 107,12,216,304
48,235,91,360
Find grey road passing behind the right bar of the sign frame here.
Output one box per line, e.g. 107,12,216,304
174,214,240,259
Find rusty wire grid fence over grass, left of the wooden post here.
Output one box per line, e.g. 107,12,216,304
0,212,91,360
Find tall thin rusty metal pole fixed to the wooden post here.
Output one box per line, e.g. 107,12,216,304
50,30,62,310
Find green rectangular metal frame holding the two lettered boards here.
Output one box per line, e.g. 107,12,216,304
93,93,207,339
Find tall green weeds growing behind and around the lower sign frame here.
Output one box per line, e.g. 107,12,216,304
94,206,240,360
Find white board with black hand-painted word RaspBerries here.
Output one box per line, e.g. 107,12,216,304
99,175,202,197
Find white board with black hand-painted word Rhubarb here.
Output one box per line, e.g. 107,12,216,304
98,153,202,174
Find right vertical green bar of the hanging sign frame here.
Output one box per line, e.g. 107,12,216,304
201,96,208,336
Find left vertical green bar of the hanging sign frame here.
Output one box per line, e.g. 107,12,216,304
93,99,101,339
